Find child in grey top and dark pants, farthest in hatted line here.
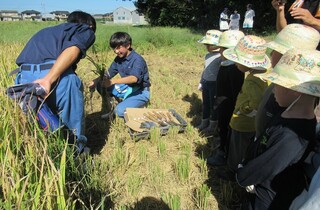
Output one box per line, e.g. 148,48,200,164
197,30,222,134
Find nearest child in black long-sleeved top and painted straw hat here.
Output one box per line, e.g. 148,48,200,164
236,49,320,210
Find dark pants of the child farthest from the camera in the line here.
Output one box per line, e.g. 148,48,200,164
201,80,218,121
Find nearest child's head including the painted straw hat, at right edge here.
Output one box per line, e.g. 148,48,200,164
257,49,320,107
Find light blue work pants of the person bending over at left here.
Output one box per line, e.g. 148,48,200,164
15,61,87,144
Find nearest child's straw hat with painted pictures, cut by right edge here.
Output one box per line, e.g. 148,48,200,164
255,49,320,97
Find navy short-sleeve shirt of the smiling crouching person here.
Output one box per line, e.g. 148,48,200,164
109,50,151,87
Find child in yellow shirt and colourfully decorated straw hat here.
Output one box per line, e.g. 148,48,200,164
220,35,271,180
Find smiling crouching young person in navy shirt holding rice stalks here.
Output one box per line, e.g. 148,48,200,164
91,32,151,117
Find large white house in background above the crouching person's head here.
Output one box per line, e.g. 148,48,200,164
113,7,147,25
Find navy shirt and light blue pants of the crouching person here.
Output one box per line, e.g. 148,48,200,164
108,50,151,117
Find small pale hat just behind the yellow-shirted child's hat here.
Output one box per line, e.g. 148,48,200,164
217,30,244,48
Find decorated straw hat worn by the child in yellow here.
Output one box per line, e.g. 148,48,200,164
223,35,271,70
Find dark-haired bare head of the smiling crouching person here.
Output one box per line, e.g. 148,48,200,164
109,32,132,58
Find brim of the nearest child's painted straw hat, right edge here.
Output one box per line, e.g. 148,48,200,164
255,71,320,97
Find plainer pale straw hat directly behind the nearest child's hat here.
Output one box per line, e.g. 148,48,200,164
266,23,320,54
